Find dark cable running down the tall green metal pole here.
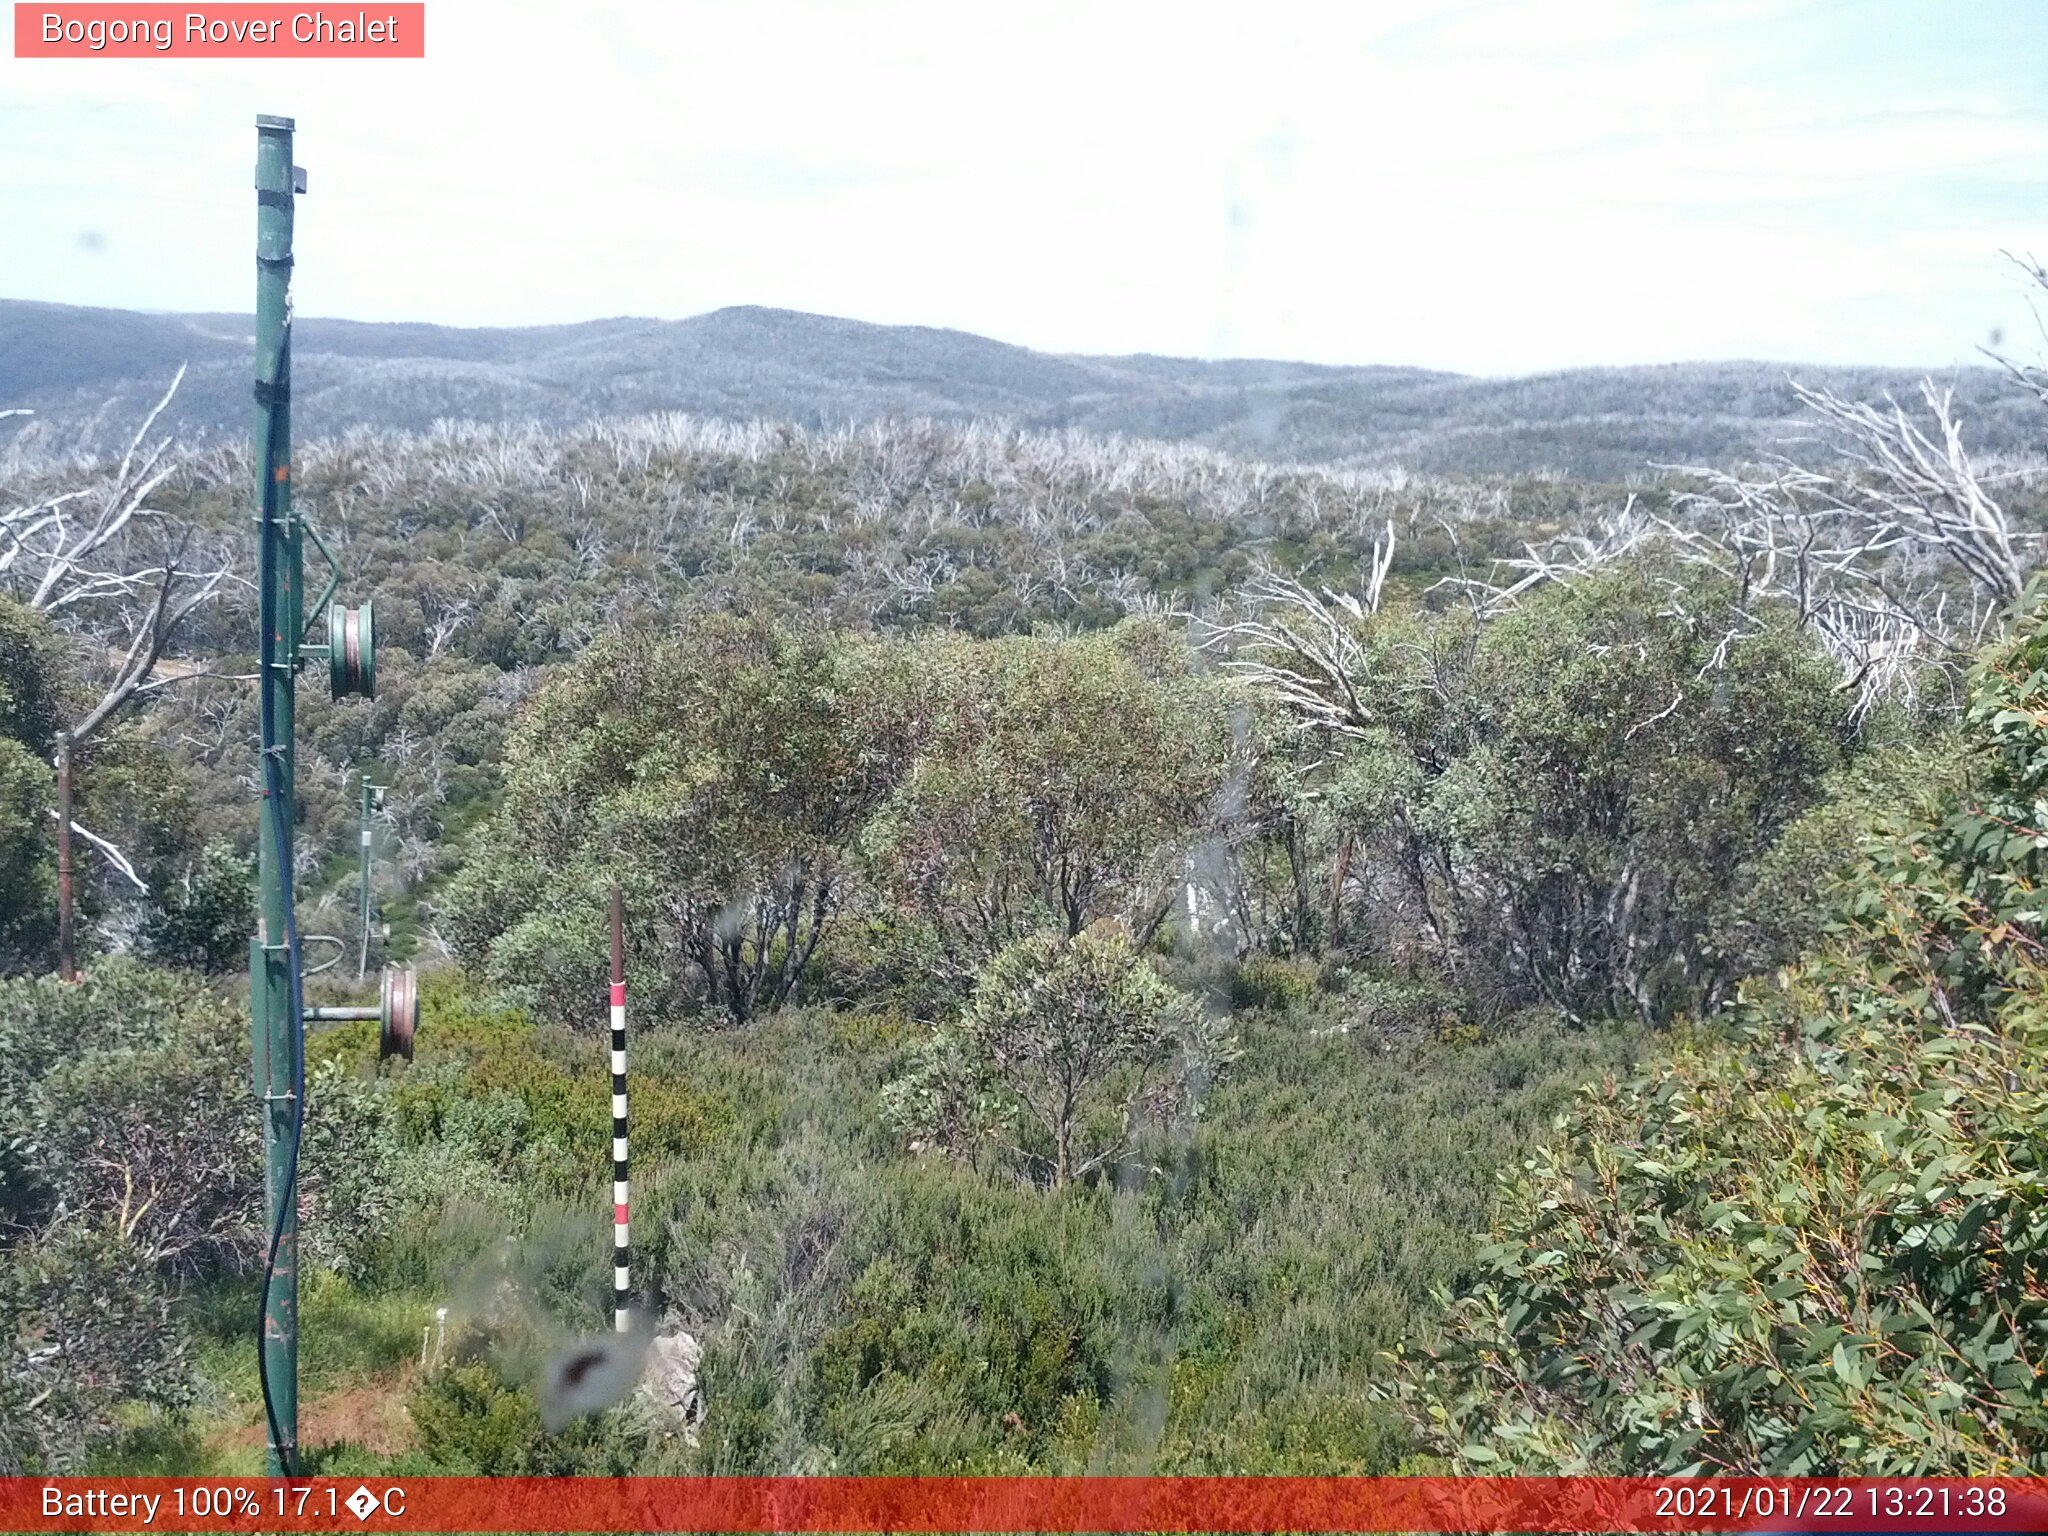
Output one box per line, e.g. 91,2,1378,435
256,333,305,1477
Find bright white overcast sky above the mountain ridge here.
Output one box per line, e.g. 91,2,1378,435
0,0,2048,373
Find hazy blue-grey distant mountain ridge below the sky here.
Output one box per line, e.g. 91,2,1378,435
0,299,2048,477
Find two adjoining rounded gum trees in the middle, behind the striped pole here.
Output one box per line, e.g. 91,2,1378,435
446,612,1223,1020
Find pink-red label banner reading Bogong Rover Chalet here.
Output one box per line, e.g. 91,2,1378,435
14,0,426,59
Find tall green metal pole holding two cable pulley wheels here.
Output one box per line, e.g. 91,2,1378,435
250,117,305,1475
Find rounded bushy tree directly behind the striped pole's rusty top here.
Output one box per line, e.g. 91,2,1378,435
449,614,891,1020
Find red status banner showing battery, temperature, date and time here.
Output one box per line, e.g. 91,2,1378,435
0,1477,2048,1536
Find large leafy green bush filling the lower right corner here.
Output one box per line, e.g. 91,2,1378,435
1419,593,2048,1475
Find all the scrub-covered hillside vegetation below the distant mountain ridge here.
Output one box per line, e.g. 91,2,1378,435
0,315,2048,1473
